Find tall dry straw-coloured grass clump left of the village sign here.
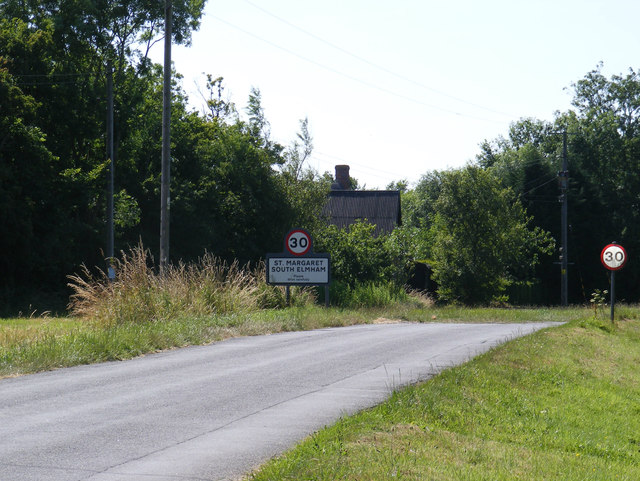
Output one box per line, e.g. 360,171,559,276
69,245,314,325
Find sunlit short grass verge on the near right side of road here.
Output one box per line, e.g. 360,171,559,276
244,307,640,481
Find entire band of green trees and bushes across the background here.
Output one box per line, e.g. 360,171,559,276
0,0,640,307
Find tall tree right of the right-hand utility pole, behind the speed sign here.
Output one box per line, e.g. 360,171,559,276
561,66,640,301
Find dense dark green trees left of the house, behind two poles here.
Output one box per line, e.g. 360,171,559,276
0,0,329,306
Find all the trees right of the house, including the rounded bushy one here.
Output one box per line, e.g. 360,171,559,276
403,66,640,304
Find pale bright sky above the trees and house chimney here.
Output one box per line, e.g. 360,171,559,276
151,0,640,189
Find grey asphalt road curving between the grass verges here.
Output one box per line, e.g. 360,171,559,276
0,323,550,481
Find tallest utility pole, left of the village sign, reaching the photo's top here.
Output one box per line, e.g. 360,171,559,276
160,0,172,272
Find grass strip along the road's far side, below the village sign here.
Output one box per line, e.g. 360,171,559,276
0,300,587,378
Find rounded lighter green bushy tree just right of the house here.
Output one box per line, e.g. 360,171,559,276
432,166,553,304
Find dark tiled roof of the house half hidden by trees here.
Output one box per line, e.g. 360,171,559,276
323,190,401,234
